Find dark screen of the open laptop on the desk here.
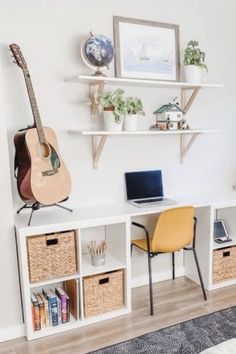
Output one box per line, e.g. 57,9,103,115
125,170,163,200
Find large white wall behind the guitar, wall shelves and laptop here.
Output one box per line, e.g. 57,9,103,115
0,0,236,338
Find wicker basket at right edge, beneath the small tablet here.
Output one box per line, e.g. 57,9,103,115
213,246,236,284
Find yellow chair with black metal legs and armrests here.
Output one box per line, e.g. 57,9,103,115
131,206,207,315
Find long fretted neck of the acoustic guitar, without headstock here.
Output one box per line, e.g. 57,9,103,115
23,69,46,144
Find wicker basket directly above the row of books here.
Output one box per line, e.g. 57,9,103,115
27,231,77,283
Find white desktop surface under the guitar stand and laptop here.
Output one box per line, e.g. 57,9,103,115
15,191,236,232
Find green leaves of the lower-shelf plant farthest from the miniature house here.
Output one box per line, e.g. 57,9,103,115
96,89,126,124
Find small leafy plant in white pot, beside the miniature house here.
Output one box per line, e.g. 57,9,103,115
124,97,145,131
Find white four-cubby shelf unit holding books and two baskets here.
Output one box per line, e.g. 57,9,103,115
16,217,131,340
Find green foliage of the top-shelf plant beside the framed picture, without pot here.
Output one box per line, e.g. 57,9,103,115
184,41,208,71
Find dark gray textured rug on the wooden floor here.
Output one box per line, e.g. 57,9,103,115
88,307,236,354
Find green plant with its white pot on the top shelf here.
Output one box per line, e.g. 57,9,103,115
184,41,208,84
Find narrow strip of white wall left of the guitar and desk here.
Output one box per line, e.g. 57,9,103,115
0,57,22,334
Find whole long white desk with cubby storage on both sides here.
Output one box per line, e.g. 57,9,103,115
15,191,236,339
